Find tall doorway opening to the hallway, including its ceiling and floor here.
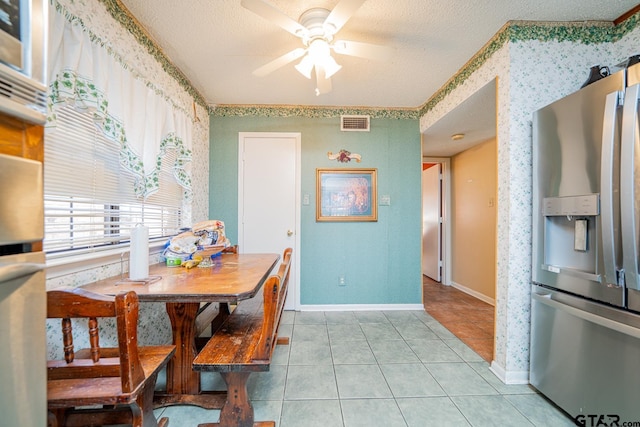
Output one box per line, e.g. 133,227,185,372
422,78,498,362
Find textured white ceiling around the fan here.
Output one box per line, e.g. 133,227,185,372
121,0,637,108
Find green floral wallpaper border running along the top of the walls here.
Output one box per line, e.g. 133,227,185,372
100,0,640,119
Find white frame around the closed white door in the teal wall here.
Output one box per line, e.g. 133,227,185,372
238,132,302,311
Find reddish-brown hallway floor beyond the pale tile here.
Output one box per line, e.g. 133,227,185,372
422,276,495,363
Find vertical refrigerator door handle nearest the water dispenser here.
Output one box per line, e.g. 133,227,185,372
600,91,620,285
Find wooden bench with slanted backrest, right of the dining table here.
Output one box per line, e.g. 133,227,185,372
193,248,291,427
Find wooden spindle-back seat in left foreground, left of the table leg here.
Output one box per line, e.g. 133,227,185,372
47,288,175,427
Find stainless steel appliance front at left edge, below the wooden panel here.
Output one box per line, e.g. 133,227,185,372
0,152,47,427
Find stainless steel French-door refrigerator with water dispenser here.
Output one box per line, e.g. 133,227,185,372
530,61,640,425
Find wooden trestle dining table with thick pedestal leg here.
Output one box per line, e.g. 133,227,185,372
83,253,280,409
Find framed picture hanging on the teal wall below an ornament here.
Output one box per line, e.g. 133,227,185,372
316,169,378,221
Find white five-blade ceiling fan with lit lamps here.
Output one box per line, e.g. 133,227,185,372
241,0,389,95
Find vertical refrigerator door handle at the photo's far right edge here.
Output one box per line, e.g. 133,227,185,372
620,85,640,290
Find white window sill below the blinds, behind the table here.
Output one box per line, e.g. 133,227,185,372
47,240,166,279
